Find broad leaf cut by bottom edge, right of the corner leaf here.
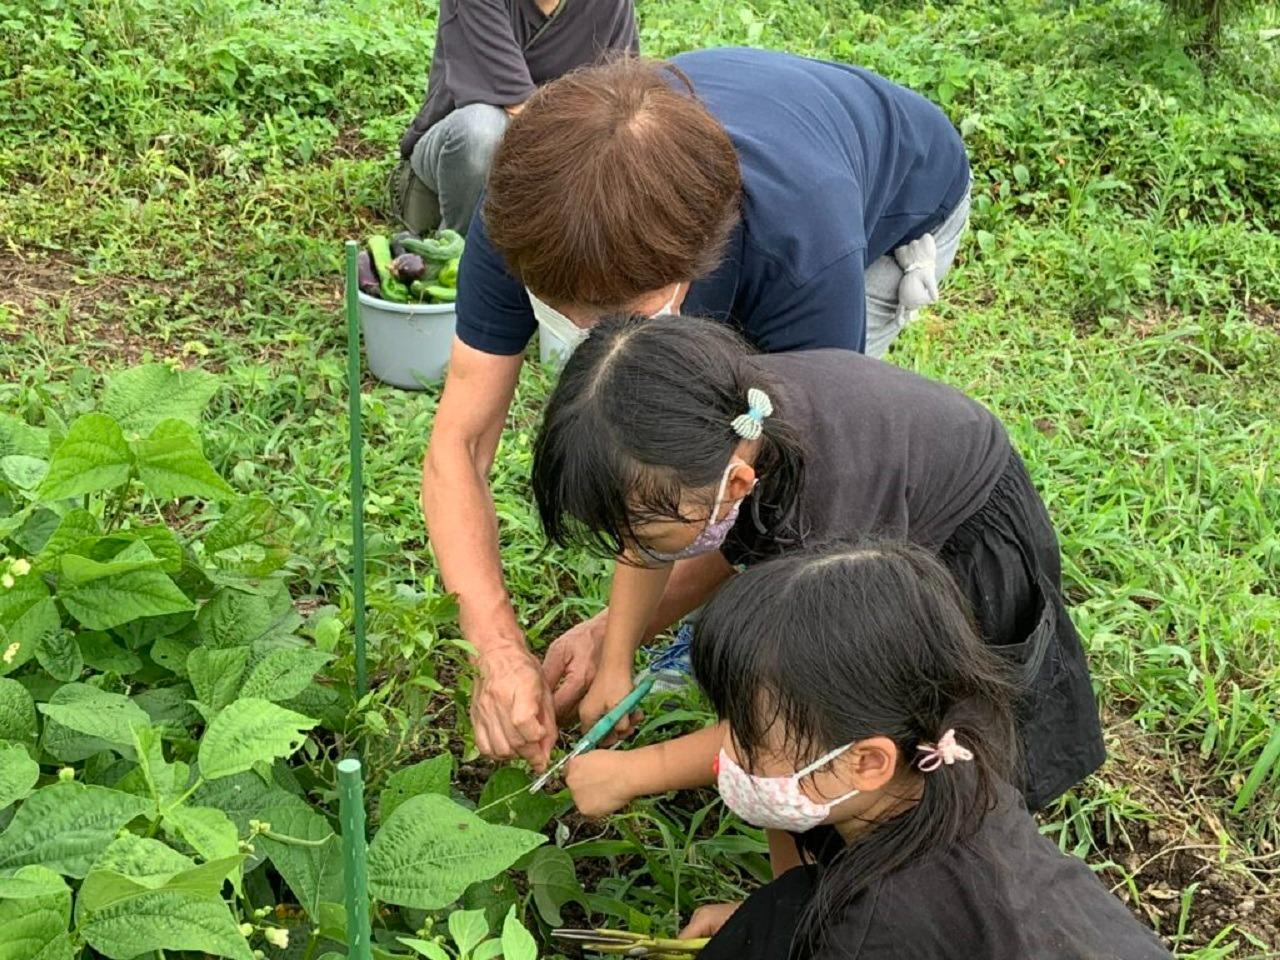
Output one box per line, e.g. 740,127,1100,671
77,890,253,960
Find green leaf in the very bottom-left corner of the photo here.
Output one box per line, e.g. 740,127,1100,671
0,865,72,960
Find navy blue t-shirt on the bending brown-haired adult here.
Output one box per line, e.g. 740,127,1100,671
457,47,969,356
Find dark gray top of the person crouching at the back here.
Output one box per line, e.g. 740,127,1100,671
401,0,640,157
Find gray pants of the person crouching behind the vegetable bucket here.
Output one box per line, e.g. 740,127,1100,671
396,104,508,233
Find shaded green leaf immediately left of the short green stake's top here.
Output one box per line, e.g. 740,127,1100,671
253,794,342,916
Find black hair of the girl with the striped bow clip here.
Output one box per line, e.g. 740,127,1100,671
532,316,804,556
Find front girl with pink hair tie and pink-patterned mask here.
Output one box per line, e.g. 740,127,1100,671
680,543,1170,960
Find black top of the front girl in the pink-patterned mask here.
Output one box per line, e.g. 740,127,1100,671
700,788,1171,960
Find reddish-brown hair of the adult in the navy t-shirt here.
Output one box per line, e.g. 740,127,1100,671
484,58,742,312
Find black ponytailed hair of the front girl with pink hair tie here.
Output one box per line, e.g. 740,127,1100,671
691,543,1015,950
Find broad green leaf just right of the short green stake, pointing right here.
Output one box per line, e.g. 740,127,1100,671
369,794,547,910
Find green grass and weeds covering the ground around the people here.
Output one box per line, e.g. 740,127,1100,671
0,0,1280,960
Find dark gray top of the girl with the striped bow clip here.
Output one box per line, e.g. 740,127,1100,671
723,349,1011,564
